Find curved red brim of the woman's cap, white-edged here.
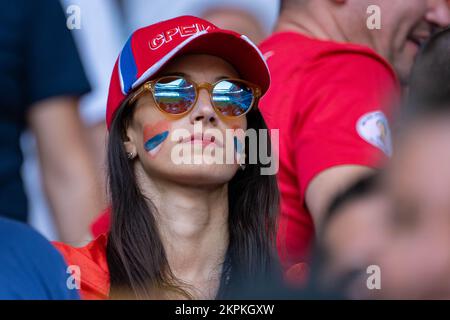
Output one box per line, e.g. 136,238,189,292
133,30,270,94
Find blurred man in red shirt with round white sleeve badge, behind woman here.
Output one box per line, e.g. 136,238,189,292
260,0,450,269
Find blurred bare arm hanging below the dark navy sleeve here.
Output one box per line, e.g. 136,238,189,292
27,97,101,243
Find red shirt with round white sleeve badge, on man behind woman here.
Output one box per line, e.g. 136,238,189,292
260,32,400,268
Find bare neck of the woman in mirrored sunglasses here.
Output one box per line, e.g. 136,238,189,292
136,170,229,299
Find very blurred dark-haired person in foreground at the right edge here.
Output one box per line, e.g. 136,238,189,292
379,29,450,299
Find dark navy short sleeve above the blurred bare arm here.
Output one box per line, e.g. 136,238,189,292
24,0,90,105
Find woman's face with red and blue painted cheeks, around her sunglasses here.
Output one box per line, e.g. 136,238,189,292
124,55,247,186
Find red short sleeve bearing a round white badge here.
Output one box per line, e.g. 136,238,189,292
295,52,399,195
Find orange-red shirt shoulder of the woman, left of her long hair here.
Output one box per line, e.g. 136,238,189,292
53,234,109,299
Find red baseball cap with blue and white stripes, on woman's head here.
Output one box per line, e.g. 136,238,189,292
106,16,270,129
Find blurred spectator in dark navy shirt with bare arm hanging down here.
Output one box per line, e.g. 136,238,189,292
0,0,99,242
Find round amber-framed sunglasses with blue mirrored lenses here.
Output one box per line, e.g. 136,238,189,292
129,76,261,118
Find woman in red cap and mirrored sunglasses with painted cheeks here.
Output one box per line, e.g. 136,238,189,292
55,16,278,299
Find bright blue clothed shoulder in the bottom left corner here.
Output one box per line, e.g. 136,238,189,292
0,218,79,300
